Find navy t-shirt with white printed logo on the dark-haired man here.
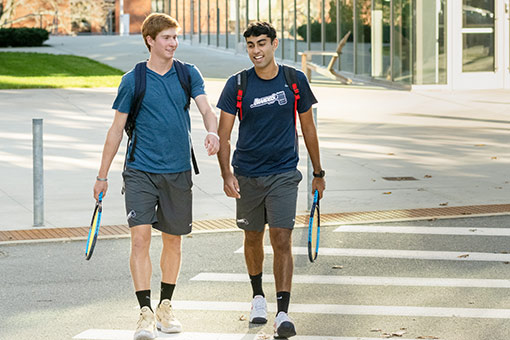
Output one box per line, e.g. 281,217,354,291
217,65,317,177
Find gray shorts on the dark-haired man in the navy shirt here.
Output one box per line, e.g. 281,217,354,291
236,170,303,231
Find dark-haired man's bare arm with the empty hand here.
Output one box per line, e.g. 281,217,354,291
218,110,241,198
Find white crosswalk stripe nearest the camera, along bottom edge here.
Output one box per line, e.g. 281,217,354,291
73,329,417,340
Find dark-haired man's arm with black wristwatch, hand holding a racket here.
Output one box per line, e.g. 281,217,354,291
299,107,326,199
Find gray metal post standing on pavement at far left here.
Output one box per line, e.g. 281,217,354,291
32,118,44,227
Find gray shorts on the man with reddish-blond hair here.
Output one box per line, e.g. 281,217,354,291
122,168,193,235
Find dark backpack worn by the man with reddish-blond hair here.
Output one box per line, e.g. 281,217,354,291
124,59,200,175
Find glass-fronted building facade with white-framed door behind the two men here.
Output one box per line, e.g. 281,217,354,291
147,0,510,89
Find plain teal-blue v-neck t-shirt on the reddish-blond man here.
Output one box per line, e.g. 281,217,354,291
113,64,205,173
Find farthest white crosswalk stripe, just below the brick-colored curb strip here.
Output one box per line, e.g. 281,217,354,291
335,225,510,236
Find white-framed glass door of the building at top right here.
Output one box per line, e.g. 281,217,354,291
452,0,508,89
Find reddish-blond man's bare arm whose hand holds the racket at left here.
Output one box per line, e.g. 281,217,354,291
94,111,128,200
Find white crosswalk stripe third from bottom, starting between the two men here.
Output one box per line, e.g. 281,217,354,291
191,273,510,288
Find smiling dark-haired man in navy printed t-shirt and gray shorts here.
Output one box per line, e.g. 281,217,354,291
217,22,326,339
